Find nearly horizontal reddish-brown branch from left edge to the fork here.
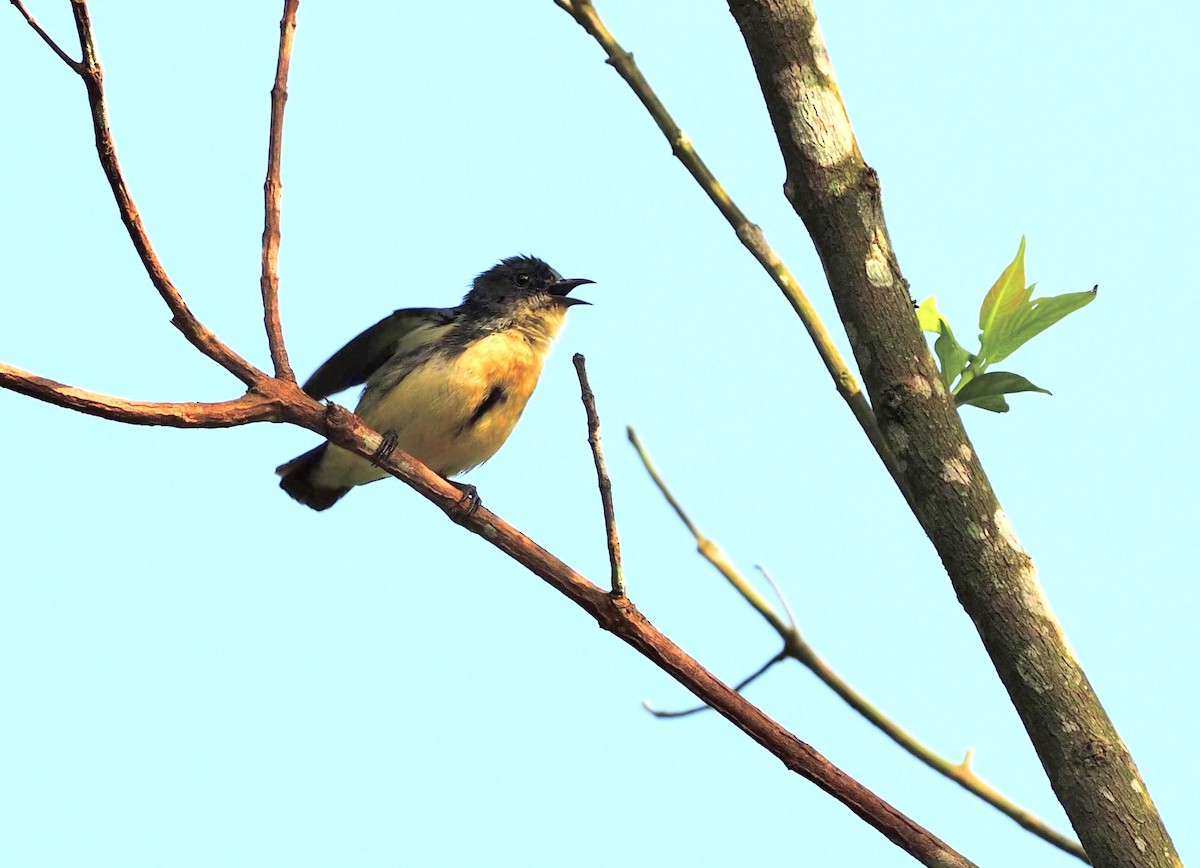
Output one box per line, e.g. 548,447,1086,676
0,363,282,427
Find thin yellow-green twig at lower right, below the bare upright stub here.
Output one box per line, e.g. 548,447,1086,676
629,429,1087,862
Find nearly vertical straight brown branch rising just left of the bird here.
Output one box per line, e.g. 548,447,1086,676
259,0,300,382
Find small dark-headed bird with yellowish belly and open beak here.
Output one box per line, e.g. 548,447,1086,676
275,256,595,511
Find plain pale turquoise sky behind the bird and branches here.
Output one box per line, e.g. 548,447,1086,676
0,0,1200,868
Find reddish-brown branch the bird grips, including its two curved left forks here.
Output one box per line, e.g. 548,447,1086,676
5,0,972,867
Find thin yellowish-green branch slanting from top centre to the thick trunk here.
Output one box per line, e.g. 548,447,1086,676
554,0,912,504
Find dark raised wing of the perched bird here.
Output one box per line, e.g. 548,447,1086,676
304,307,457,401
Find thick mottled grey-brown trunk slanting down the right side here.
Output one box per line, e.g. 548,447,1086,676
730,0,1180,868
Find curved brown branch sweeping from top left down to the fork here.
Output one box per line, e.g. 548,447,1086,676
52,0,265,385
